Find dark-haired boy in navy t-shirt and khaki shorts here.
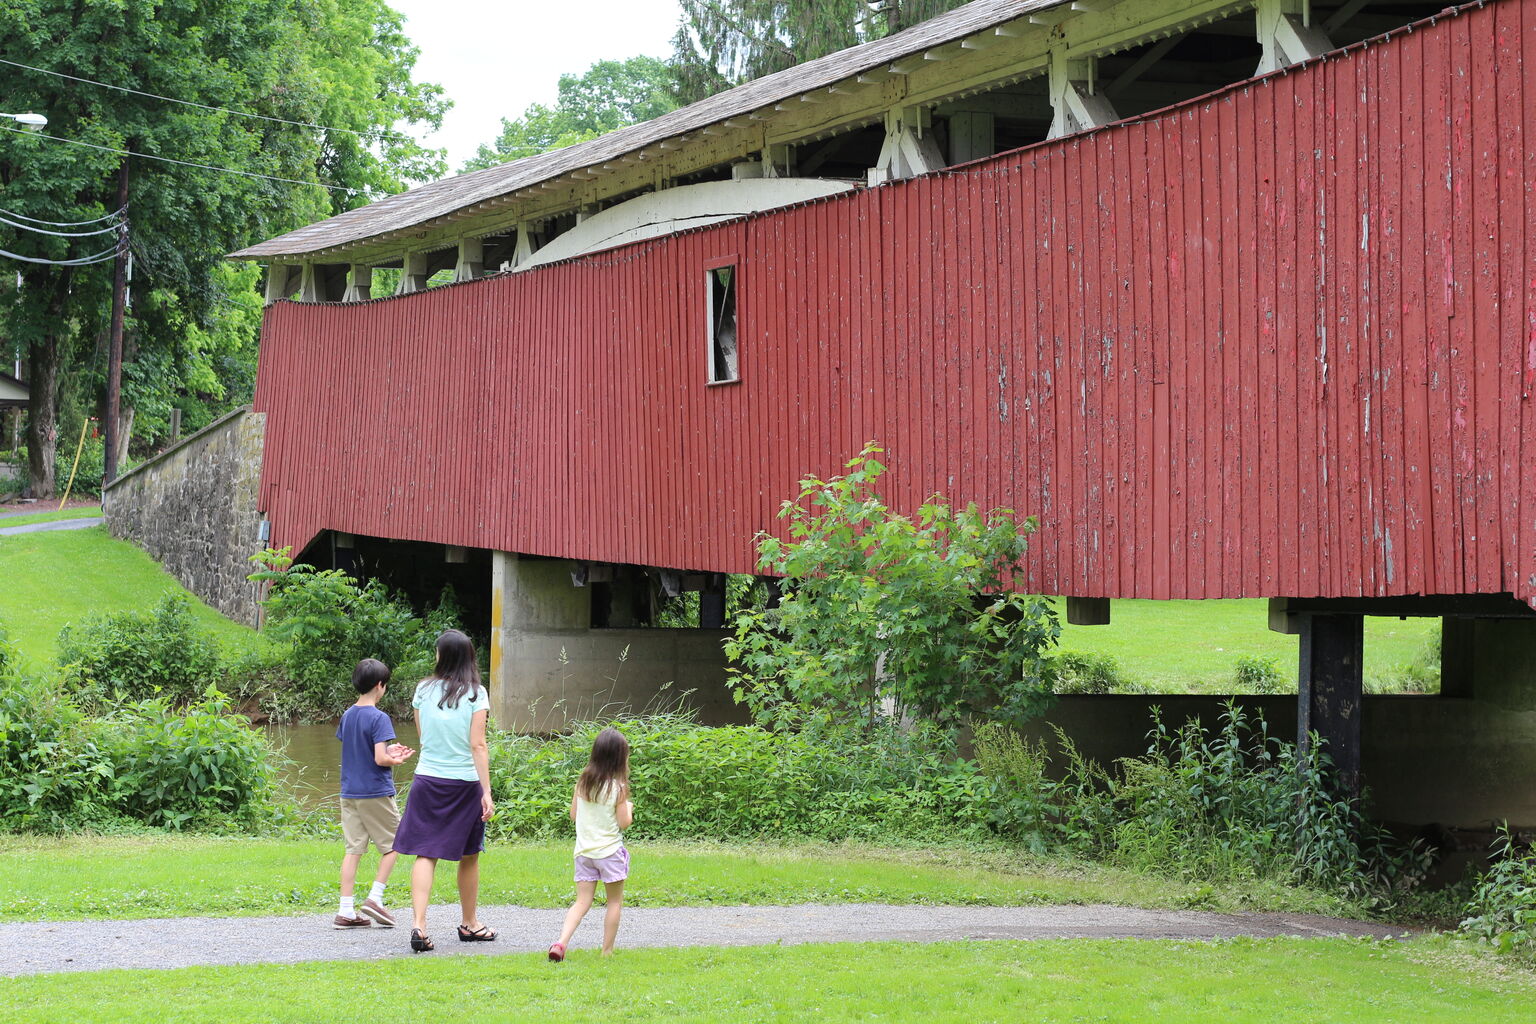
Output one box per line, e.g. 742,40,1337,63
332,657,416,929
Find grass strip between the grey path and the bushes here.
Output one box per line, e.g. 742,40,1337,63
0,837,1370,921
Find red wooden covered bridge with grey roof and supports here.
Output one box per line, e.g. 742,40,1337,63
224,0,1536,817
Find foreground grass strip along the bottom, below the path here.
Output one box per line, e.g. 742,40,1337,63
0,929,1536,1024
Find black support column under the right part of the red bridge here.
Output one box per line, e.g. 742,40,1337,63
1296,616,1366,797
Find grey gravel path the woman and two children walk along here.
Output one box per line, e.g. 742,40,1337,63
0,903,1402,976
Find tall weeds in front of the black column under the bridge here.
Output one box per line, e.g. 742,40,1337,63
975,703,1424,897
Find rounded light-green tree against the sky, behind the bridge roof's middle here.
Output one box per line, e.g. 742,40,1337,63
464,57,677,170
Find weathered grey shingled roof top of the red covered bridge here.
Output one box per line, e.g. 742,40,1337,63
230,0,1071,259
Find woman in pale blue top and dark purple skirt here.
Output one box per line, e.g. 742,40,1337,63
395,629,496,953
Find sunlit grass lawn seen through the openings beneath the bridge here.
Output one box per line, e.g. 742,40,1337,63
1061,599,1439,694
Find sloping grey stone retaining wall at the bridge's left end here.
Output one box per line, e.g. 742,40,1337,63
101,407,266,626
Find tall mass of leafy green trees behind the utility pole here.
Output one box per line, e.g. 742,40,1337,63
0,0,445,494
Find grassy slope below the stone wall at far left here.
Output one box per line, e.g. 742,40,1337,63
0,527,260,666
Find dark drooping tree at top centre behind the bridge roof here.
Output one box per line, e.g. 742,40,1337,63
671,0,969,103
